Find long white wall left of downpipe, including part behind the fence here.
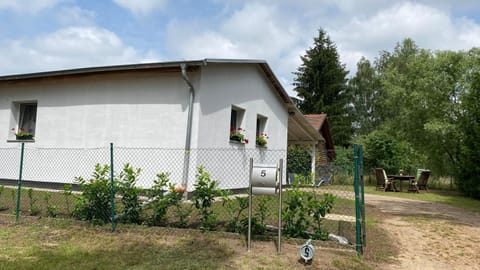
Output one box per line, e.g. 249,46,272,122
0,72,197,186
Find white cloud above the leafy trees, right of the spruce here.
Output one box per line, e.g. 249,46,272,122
327,2,480,75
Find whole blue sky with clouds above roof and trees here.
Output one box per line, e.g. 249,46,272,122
0,0,480,96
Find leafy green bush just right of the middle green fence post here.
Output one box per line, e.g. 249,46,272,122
117,163,142,224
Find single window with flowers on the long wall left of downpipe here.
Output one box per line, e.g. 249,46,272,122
11,102,37,139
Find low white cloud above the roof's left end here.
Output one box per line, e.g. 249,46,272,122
0,27,159,74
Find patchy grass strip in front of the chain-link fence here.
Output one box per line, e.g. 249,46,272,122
0,216,376,270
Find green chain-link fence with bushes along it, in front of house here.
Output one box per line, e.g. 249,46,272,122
0,144,356,251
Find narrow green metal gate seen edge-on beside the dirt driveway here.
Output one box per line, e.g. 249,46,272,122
353,144,367,254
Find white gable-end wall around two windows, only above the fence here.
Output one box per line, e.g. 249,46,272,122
197,63,288,149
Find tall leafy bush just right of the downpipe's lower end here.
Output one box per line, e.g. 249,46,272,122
192,166,225,230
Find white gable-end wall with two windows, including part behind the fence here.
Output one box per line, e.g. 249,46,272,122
184,63,288,188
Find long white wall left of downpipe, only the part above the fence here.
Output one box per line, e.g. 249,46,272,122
0,72,188,148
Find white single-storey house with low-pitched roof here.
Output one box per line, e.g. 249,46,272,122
0,59,320,190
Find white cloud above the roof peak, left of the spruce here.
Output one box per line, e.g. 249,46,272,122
166,2,304,79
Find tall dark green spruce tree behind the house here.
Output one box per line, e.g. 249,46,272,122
293,29,353,146
